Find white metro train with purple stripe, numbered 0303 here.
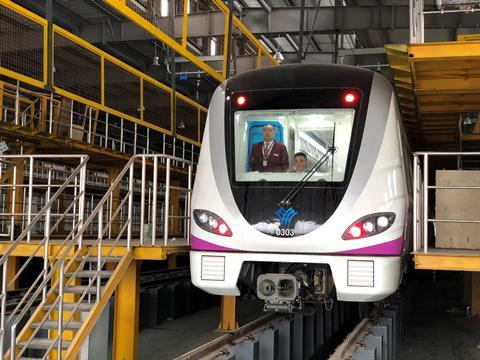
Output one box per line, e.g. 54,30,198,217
190,64,412,312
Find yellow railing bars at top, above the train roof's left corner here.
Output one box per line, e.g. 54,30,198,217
103,0,276,81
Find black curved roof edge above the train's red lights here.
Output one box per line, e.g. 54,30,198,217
226,64,375,92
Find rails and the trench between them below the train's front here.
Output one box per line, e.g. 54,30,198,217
175,288,409,360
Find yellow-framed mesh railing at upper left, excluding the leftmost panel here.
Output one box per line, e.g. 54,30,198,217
53,26,207,145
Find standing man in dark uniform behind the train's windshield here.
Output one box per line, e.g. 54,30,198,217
250,124,288,171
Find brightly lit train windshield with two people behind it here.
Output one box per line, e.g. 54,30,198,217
234,108,355,182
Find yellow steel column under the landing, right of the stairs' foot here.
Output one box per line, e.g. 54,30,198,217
112,260,140,360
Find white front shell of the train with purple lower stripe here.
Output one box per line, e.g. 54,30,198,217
191,64,410,301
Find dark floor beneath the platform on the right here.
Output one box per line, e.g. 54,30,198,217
397,271,480,360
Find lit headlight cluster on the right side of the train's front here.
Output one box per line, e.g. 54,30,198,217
342,213,395,240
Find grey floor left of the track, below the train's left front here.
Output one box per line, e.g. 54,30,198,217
138,301,263,360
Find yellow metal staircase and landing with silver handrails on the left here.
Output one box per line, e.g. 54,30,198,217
0,155,193,359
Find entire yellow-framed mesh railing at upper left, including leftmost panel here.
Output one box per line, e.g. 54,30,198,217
0,0,207,146
